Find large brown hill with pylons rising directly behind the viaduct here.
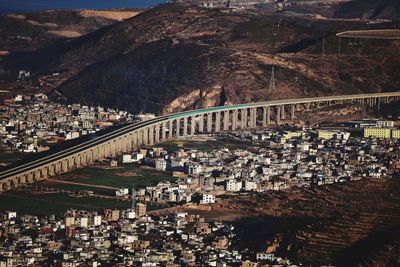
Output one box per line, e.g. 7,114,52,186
2,4,400,113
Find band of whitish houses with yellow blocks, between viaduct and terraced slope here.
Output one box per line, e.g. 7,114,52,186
116,120,400,204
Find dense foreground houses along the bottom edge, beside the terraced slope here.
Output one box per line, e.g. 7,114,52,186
0,208,289,267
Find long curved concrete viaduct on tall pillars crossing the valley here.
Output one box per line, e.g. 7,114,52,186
0,92,400,192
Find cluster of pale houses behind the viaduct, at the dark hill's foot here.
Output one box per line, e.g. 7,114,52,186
0,94,154,156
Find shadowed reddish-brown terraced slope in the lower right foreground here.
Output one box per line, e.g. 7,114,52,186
167,177,400,266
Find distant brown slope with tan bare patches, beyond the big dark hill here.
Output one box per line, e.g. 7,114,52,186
0,10,138,53
